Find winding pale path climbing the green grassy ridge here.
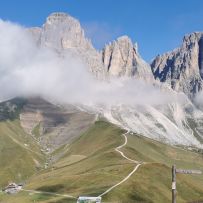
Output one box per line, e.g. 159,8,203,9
99,132,143,197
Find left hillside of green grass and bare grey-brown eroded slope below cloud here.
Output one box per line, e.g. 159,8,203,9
0,98,94,188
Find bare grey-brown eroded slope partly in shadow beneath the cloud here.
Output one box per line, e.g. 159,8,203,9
20,98,95,151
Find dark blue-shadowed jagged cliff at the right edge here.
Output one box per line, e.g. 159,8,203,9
151,32,203,97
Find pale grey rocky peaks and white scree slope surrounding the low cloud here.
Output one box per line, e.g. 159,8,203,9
28,13,203,148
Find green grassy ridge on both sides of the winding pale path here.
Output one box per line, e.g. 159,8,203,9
0,121,203,203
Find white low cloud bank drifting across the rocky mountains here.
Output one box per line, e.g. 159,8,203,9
0,20,181,105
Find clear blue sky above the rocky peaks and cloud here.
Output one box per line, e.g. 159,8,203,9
0,0,203,61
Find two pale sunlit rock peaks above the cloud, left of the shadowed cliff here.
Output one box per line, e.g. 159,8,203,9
29,13,153,80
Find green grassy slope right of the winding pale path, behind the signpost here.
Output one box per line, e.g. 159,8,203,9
106,135,203,203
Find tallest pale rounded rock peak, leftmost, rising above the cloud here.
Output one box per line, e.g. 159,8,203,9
29,13,104,78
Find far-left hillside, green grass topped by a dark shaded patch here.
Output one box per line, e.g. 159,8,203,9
0,98,45,187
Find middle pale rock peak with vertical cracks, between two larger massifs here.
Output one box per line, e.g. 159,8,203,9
102,36,153,80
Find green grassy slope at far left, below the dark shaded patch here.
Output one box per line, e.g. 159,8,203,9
0,120,43,188
